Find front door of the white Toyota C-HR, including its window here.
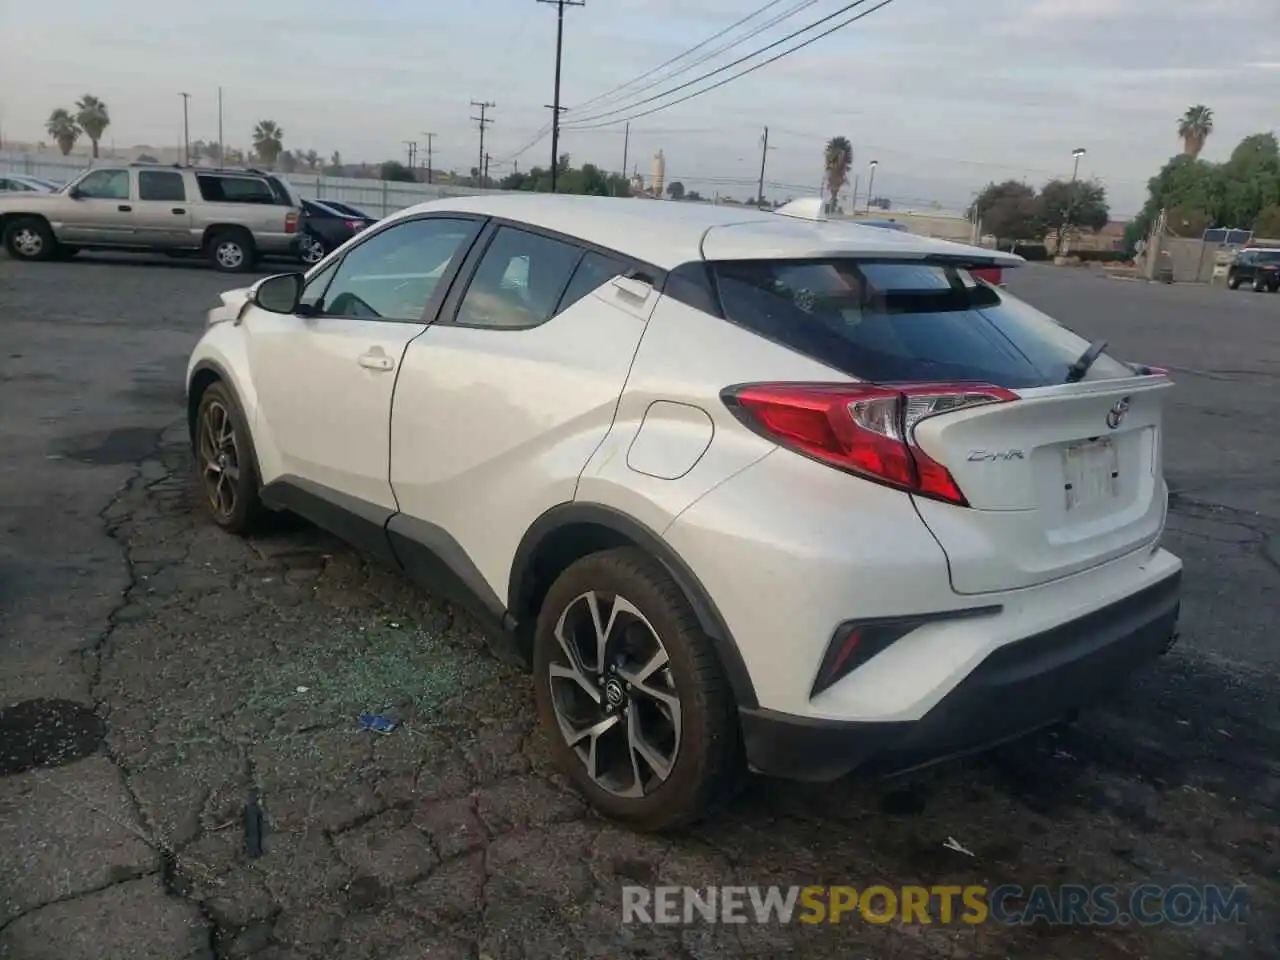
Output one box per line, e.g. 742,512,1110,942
244,216,481,526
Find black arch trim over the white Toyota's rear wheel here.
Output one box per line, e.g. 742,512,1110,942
507,502,759,709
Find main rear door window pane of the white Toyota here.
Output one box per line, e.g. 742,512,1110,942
454,227,582,330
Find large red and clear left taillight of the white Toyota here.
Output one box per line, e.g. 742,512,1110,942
721,383,1018,507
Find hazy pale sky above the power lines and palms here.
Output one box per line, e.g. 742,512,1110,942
0,0,1280,216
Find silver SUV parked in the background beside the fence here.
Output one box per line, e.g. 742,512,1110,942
0,164,302,273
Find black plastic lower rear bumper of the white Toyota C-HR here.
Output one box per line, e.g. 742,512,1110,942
741,568,1181,781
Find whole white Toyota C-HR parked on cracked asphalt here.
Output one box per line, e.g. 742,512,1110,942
187,195,1181,829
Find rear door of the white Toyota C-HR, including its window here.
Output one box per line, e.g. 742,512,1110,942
388,225,658,603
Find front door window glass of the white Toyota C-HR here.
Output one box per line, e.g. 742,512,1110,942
314,218,476,320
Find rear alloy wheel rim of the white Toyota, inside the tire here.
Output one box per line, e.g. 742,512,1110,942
548,590,681,797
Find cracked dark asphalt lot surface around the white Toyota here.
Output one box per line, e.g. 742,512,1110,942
0,257,1280,960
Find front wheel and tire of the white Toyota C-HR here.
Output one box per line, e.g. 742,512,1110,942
192,383,264,535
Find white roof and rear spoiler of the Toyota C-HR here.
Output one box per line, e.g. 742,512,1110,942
393,193,1025,270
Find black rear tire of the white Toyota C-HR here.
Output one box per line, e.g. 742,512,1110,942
534,548,745,832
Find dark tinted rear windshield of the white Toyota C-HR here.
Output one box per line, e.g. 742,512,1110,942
710,259,1134,388
